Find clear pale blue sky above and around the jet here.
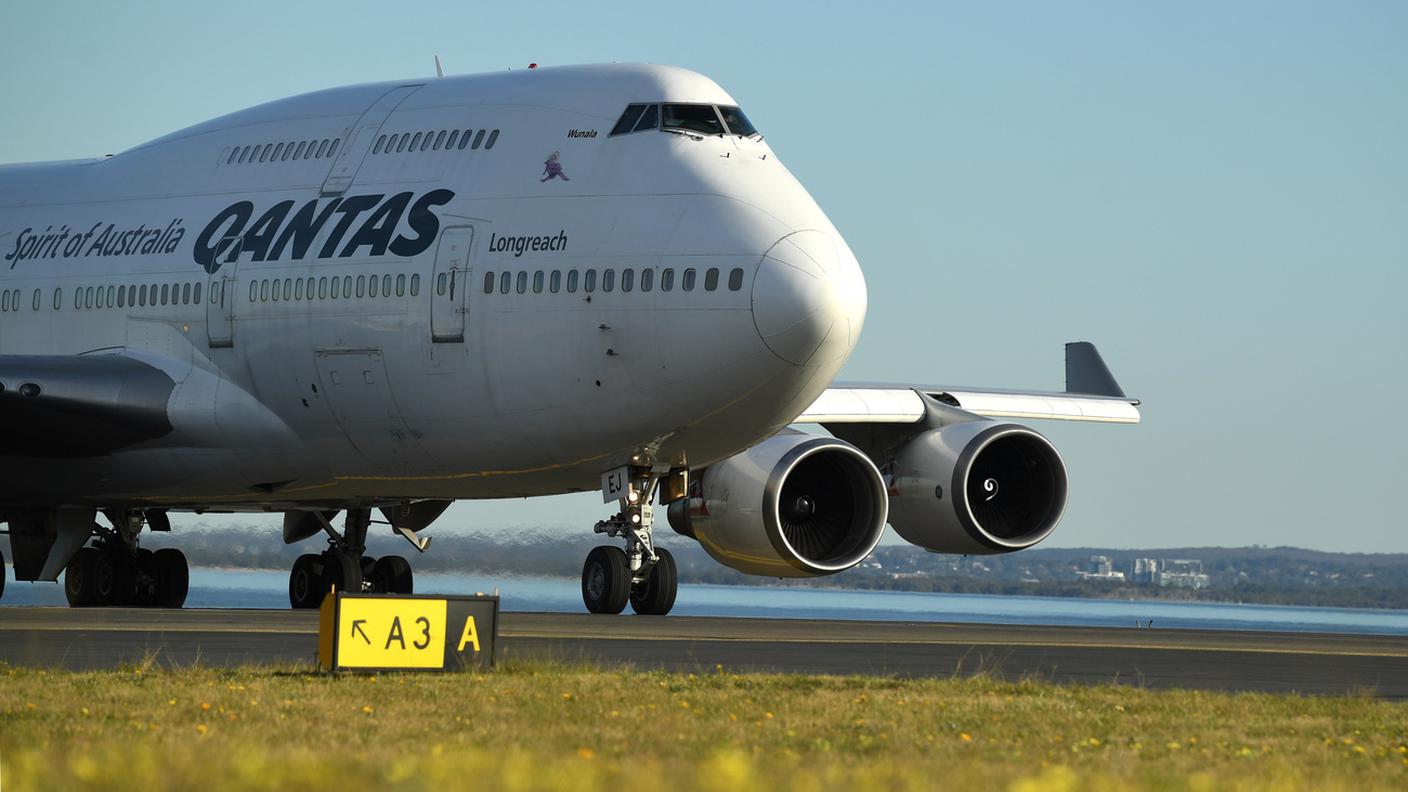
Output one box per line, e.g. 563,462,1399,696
0,0,1408,552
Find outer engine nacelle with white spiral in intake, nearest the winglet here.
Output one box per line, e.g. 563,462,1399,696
888,420,1066,554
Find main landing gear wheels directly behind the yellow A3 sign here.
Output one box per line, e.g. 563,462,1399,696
289,509,414,609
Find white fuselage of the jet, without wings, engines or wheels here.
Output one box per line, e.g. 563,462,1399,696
0,60,866,509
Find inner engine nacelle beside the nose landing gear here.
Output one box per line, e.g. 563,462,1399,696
669,431,888,578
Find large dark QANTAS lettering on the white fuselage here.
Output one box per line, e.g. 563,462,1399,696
191,190,455,272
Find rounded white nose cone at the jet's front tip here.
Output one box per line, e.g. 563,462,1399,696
753,231,866,365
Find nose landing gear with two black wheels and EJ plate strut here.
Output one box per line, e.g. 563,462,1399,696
582,468,679,616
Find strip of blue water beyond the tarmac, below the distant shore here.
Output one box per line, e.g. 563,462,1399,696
0,568,1408,636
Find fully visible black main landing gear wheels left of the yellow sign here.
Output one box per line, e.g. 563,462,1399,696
63,514,190,607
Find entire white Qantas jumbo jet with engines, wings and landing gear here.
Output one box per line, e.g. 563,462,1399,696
0,65,1139,614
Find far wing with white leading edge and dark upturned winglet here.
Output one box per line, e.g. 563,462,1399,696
794,341,1139,424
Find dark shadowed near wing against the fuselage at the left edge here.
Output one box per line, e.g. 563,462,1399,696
0,354,175,458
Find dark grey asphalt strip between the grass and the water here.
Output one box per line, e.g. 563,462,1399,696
0,607,1408,699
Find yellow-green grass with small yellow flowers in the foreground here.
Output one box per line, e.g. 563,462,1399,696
0,664,1408,792
